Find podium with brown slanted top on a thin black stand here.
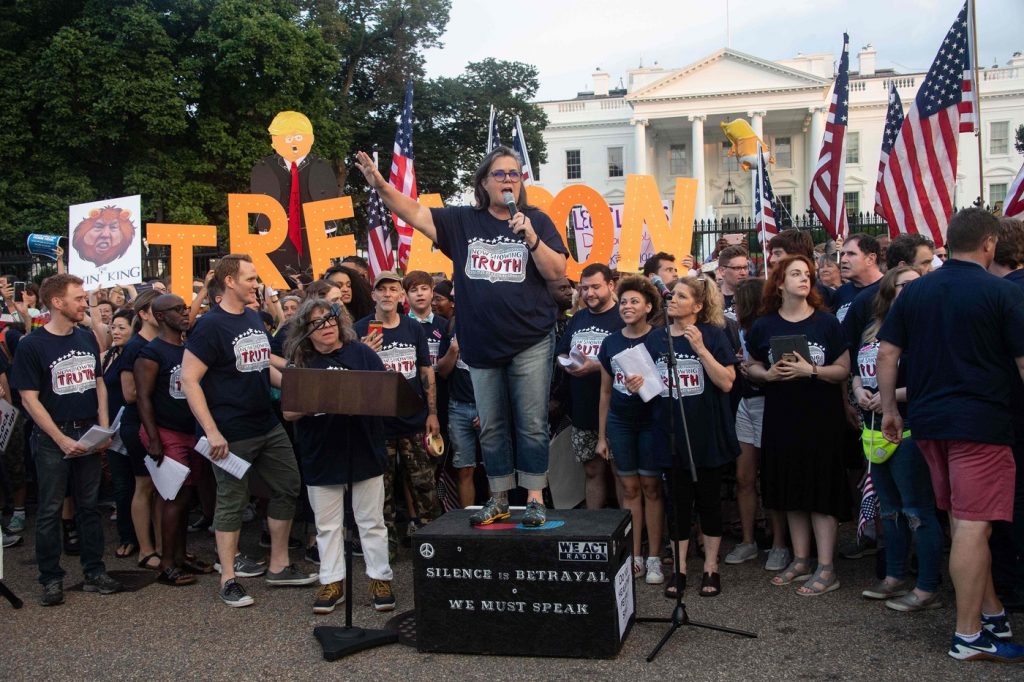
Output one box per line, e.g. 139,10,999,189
281,368,423,660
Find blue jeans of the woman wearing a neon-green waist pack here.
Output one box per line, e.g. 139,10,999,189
871,438,943,592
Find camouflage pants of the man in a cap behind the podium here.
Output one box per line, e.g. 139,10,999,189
384,433,441,546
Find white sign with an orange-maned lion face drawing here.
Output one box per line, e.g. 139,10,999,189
68,195,142,291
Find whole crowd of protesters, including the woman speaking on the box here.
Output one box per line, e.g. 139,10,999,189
0,147,1024,660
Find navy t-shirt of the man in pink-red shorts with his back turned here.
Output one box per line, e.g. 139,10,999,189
879,258,1024,444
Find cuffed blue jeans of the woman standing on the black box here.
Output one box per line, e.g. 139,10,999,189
469,332,555,493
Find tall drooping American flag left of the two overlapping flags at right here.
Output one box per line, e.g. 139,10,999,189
811,33,850,239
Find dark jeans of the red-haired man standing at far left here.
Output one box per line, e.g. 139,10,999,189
33,428,106,585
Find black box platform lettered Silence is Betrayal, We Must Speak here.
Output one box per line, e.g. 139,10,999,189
413,509,636,658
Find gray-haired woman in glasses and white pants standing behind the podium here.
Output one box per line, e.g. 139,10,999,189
284,298,395,613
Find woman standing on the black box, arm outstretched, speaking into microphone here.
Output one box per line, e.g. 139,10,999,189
355,146,567,526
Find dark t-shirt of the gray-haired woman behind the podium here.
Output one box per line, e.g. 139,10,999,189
295,341,387,485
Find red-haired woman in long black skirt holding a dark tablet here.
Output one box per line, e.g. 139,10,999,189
746,255,852,597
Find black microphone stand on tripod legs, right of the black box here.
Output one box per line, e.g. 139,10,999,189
636,319,757,663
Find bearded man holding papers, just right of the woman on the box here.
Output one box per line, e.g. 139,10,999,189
557,263,624,509
